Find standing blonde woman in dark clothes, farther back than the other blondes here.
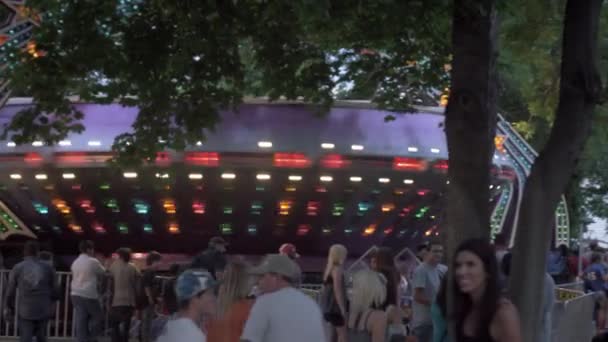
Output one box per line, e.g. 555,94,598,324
321,245,348,342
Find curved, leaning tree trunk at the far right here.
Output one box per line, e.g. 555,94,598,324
509,0,602,342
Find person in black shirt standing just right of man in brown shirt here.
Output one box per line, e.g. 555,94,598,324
141,251,162,342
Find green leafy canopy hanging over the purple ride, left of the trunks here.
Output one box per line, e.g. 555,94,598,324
2,0,450,163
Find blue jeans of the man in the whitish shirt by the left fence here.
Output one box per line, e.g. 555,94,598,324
72,296,103,342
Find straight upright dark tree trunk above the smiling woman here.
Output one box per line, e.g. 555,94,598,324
445,0,497,256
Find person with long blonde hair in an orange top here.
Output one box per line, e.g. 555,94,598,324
207,261,254,342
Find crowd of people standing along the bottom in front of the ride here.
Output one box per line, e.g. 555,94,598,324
4,235,608,342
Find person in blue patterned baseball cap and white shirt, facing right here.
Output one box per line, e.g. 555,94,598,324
156,270,218,342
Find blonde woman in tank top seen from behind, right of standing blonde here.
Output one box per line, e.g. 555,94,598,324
348,269,387,342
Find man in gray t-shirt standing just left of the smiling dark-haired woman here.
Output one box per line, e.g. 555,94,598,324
412,243,446,342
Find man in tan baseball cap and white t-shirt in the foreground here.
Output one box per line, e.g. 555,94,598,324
241,254,326,342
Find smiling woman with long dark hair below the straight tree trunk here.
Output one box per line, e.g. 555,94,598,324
449,239,522,342
